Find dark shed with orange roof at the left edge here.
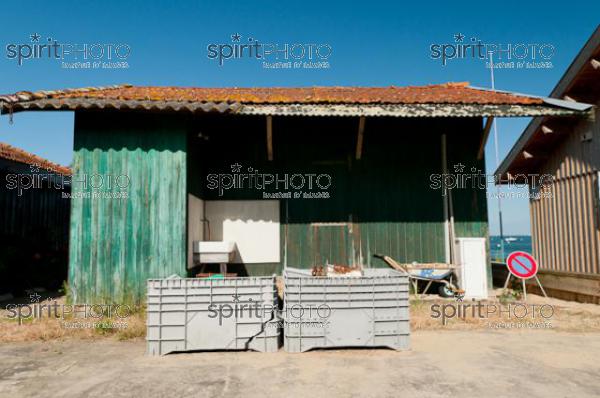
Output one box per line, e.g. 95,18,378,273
0,143,71,295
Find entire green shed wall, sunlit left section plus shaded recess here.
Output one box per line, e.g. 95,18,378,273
69,112,487,302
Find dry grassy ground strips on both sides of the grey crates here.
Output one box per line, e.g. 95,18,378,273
0,290,600,344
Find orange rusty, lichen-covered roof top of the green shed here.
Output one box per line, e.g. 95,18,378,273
0,83,543,105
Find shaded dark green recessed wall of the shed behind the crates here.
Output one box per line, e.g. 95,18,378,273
190,113,488,273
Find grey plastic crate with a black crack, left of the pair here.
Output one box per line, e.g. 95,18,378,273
146,276,280,355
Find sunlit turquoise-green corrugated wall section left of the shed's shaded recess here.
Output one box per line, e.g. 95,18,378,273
69,112,187,302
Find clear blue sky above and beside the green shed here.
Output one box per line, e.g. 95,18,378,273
0,1,600,234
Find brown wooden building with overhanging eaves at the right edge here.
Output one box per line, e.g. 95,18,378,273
497,27,600,303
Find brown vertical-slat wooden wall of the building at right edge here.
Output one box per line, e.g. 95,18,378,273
530,111,600,274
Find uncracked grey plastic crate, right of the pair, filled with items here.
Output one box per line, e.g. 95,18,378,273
283,268,410,352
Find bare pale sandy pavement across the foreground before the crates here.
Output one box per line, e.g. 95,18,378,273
0,330,600,398
